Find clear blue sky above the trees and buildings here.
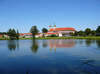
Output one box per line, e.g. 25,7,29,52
0,0,100,33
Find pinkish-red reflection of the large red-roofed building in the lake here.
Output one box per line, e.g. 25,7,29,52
49,39,75,51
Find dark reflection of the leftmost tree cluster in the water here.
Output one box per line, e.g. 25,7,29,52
8,40,19,51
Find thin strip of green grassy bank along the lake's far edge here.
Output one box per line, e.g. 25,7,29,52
0,36,100,40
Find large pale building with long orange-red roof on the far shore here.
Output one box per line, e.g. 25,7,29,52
45,27,76,37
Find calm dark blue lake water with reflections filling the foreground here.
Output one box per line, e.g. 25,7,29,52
0,40,100,74
